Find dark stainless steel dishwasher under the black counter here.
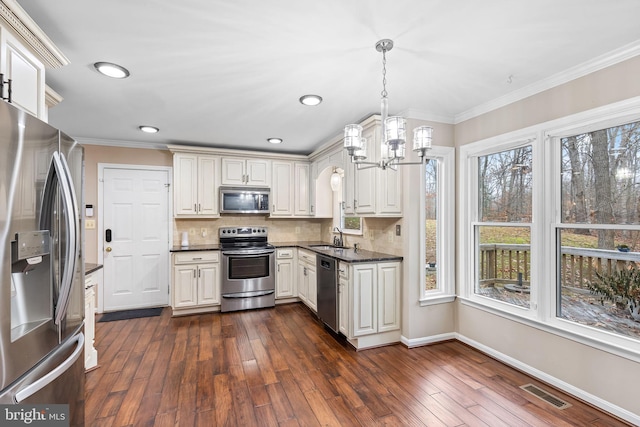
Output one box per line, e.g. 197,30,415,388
317,254,338,332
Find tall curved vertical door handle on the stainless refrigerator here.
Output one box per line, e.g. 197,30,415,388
40,152,79,325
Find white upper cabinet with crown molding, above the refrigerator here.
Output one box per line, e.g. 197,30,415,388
0,0,69,120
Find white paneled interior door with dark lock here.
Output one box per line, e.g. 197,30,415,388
102,167,169,311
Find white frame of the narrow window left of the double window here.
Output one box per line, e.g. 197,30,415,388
419,146,456,306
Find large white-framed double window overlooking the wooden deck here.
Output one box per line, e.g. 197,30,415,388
458,99,640,360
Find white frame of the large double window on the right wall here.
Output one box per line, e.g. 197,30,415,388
456,97,640,362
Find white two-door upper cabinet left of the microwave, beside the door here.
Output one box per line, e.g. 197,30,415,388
173,153,220,217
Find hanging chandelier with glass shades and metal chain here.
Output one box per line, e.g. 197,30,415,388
344,39,433,170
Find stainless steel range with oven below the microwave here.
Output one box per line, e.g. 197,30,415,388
218,226,276,312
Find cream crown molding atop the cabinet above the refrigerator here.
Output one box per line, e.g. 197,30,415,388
0,0,69,68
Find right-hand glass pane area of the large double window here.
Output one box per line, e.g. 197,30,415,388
556,122,640,339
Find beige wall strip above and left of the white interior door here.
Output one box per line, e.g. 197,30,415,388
84,145,173,263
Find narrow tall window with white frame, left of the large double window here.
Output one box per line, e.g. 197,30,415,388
420,147,455,305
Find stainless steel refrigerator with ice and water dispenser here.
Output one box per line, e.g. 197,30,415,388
0,101,84,425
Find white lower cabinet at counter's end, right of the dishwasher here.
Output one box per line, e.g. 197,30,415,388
338,262,401,349
